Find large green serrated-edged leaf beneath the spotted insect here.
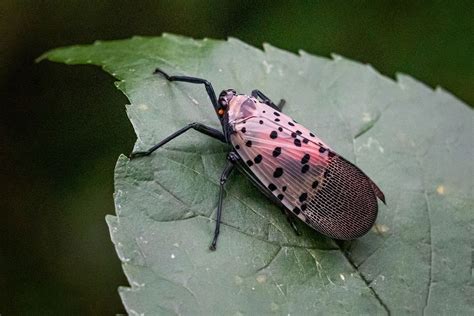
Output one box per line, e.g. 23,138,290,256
43,34,474,315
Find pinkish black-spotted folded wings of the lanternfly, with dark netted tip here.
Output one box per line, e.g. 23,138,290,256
231,106,384,240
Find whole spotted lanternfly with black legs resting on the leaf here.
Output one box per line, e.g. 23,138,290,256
130,69,385,250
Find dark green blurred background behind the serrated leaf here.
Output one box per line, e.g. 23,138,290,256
0,0,474,315
